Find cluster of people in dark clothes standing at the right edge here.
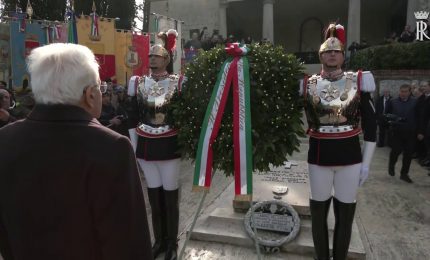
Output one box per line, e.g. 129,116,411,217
376,81,430,183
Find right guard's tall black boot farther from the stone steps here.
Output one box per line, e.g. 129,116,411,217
333,198,357,260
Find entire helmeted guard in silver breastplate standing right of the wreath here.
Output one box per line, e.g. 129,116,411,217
302,24,376,260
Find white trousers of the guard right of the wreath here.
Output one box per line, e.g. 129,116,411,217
309,163,361,203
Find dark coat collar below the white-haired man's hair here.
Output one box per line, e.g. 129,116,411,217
27,104,97,122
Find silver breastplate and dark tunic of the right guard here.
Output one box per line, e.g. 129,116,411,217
302,71,376,166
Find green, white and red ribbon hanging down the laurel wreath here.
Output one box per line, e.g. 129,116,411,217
193,43,252,201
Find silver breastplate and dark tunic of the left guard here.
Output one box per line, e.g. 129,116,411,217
128,75,180,161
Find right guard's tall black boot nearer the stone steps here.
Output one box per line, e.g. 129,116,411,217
310,197,331,260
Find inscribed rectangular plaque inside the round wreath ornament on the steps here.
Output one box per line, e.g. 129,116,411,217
252,212,294,233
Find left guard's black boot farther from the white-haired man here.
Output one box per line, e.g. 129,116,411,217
164,190,179,260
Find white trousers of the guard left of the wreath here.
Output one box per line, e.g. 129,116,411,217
137,158,180,190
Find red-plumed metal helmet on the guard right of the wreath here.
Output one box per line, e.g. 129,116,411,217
319,23,346,55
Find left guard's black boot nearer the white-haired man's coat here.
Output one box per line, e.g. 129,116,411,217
148,187,167,258
